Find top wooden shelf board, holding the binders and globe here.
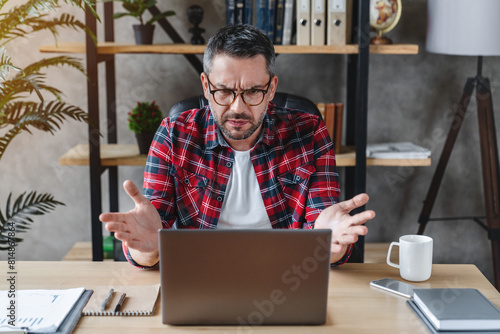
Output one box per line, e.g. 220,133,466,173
39,42,418,55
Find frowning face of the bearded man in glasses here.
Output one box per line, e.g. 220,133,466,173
201,55,278,150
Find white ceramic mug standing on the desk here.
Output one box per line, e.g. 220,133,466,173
387,235,432,282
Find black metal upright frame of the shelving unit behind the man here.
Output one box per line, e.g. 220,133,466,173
85,0,370,261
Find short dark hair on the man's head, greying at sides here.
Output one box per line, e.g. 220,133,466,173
203,24,276,77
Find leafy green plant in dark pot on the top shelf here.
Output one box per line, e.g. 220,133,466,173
104,0,175,44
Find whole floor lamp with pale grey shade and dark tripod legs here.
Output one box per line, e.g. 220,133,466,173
418,0,500,289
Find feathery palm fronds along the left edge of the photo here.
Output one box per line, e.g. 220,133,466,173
0,0,99,250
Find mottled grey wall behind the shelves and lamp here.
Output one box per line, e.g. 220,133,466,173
0,0,500,279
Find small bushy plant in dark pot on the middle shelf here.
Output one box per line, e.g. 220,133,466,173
128,101,163,154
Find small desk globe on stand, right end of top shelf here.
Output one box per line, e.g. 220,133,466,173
370,0,401,44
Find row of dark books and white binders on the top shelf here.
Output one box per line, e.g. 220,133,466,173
226,0,352,45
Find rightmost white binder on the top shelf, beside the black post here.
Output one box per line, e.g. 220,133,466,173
326,0,352,45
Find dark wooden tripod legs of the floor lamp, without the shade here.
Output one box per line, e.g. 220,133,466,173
418,56,500,290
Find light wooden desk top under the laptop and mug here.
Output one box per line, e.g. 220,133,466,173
0,261,500,334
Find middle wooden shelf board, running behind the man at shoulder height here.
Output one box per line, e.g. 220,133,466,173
59,144,431,167
